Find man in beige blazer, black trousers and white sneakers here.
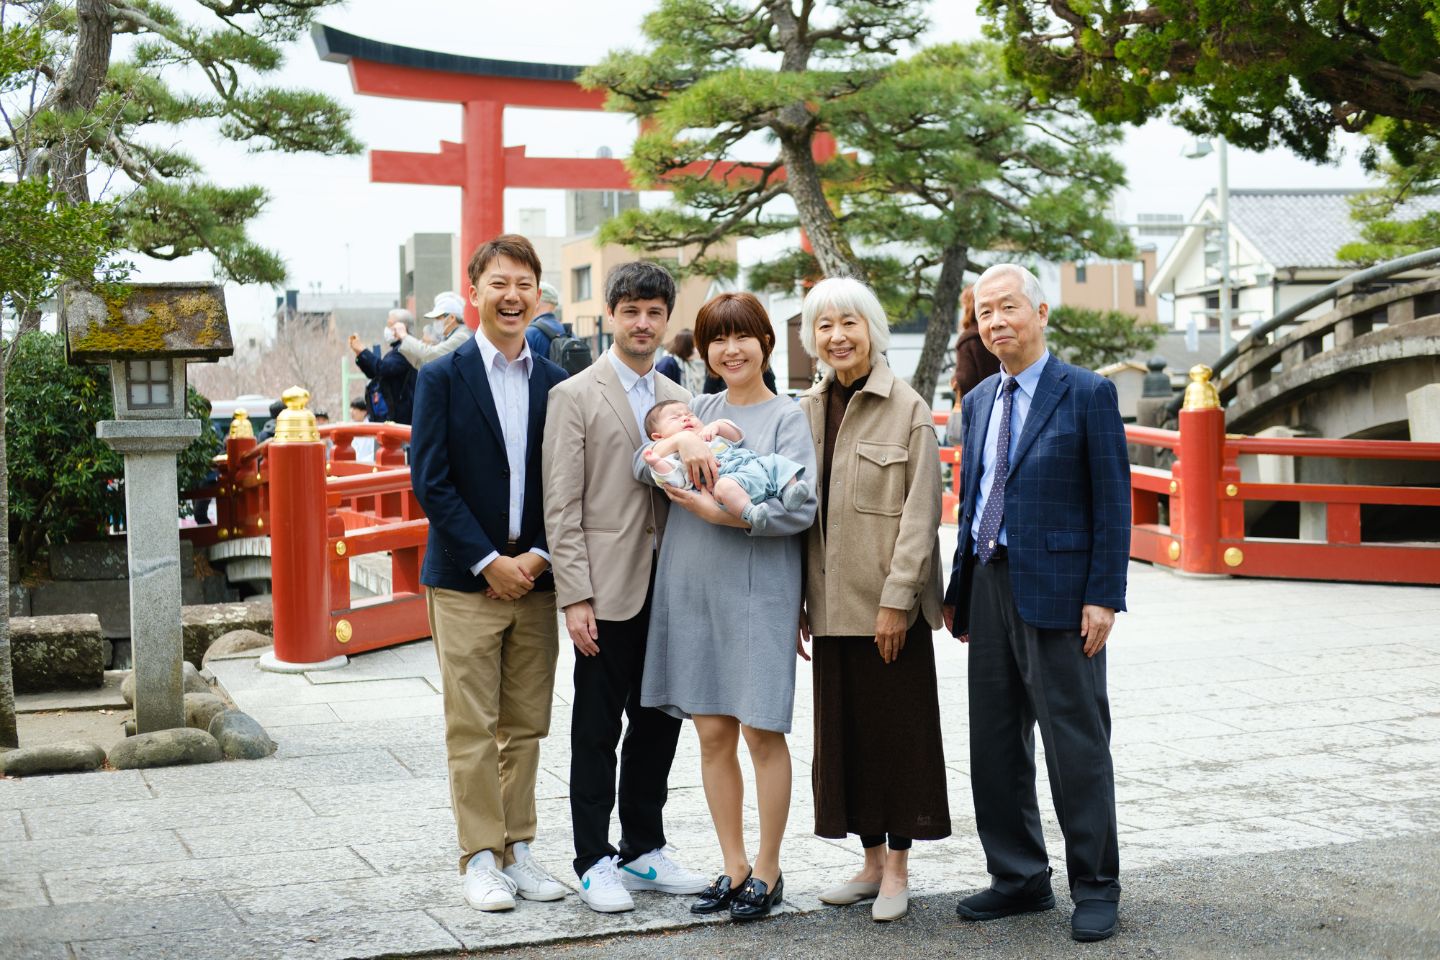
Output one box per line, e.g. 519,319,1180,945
543,262,706,913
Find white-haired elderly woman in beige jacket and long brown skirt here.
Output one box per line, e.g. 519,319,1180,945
799,278,950,921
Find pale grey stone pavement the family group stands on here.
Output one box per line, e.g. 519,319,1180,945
0,531,1440,960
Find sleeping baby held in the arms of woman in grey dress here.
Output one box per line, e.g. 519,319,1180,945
644,400,809,530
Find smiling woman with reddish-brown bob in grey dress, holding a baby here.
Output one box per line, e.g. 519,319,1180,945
635,294,816,920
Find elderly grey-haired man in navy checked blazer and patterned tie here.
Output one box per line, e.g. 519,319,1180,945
945,263,1130,941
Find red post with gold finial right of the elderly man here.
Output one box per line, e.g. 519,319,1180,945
1174,364,1225,573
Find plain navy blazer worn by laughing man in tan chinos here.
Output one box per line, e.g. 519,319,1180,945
410,337,566,593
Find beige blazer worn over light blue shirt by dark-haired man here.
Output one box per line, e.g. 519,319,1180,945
541,356,690,620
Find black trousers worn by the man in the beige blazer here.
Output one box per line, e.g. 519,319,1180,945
570,583,680,877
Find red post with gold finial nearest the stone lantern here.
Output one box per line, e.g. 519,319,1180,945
261,387,348,672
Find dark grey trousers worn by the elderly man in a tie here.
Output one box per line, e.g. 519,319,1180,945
969,560,1120,901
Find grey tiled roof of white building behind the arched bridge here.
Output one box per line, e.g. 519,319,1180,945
1207,190,1440,269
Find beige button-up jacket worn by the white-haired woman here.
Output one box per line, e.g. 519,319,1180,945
801,360,943,636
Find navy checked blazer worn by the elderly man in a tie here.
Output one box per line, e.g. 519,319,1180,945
945,354,1130,635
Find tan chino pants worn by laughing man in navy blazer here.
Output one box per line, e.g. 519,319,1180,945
425,587,560,872
